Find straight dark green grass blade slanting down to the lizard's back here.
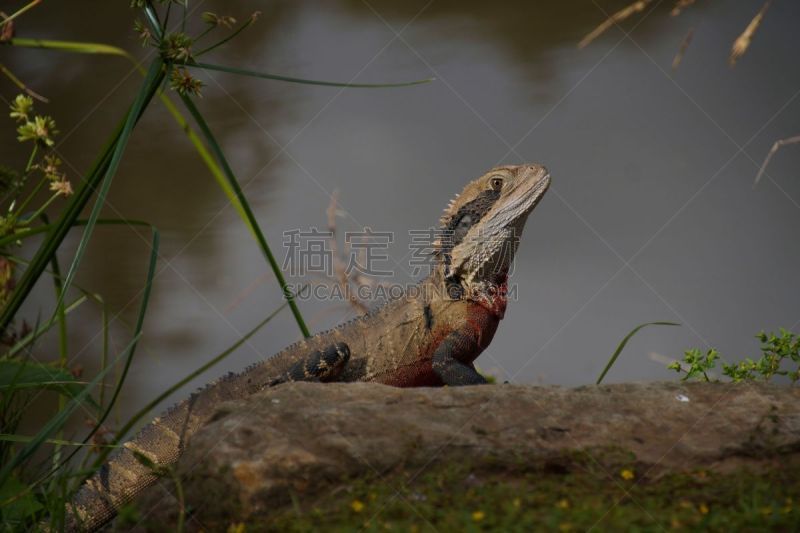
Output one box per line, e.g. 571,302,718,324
181,96,311,337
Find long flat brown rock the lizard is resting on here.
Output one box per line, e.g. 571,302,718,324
138,383,800,524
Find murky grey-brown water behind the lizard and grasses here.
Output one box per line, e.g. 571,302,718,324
0,0,800,426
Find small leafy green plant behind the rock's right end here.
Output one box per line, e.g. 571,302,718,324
667,328,800,385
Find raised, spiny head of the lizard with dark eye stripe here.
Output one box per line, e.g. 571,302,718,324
436,164,550,289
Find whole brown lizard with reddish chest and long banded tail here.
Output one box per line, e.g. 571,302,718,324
66,164,550,531
